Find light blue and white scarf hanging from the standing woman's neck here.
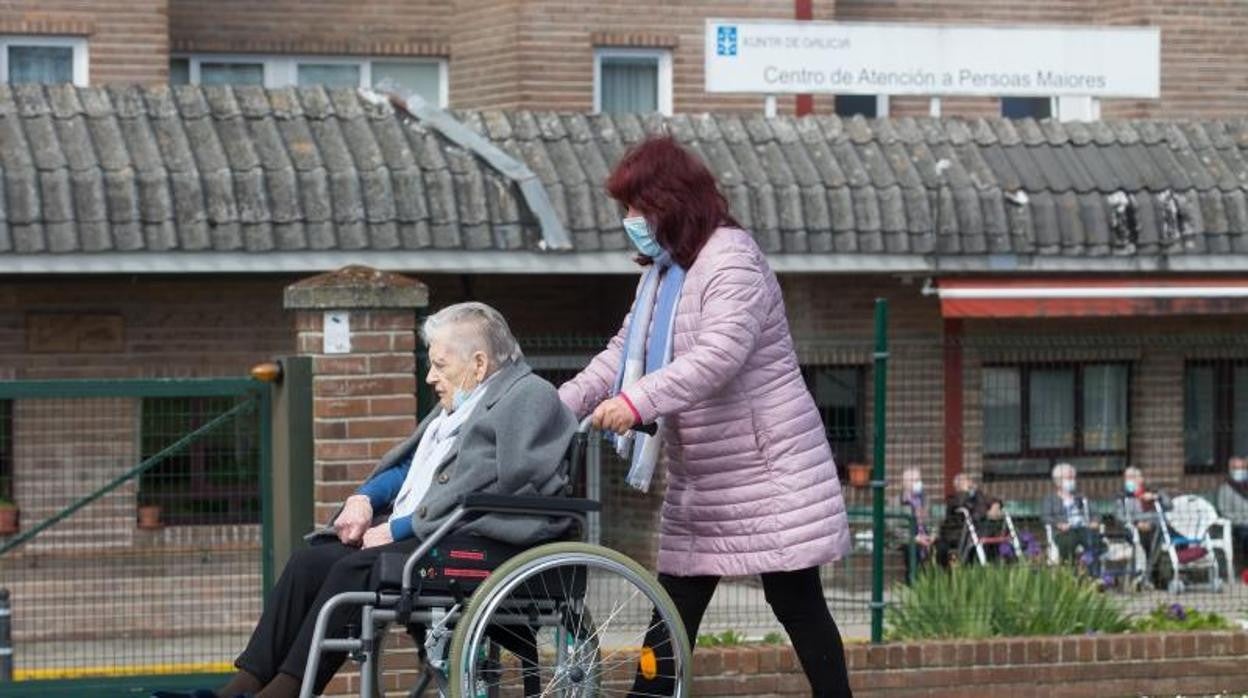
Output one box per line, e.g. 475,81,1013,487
615,251,685,492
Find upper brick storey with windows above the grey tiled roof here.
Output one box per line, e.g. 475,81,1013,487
7,0,1248,119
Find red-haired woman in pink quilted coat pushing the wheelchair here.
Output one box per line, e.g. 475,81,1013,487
559,137,851,697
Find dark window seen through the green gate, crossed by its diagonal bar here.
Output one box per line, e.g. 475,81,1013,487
139,397,260,524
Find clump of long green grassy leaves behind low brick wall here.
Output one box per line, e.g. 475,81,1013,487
886,563,1131,639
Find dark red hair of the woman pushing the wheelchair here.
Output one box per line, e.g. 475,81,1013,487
607,136,739,268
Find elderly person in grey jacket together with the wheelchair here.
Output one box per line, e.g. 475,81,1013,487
156,303,689,698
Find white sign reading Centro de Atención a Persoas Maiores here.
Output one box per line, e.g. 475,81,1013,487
706,19,1161,99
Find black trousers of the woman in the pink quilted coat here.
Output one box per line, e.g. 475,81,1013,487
631,567,854,698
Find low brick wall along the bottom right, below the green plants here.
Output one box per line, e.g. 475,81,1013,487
678,632,1248,698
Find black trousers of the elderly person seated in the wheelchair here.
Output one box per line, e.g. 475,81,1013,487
235,538,419,694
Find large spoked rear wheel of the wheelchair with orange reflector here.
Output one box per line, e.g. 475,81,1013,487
449,543,693,698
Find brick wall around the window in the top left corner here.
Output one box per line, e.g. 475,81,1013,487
0,0,168,84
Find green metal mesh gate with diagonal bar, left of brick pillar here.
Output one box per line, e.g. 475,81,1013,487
0,378,272,697
